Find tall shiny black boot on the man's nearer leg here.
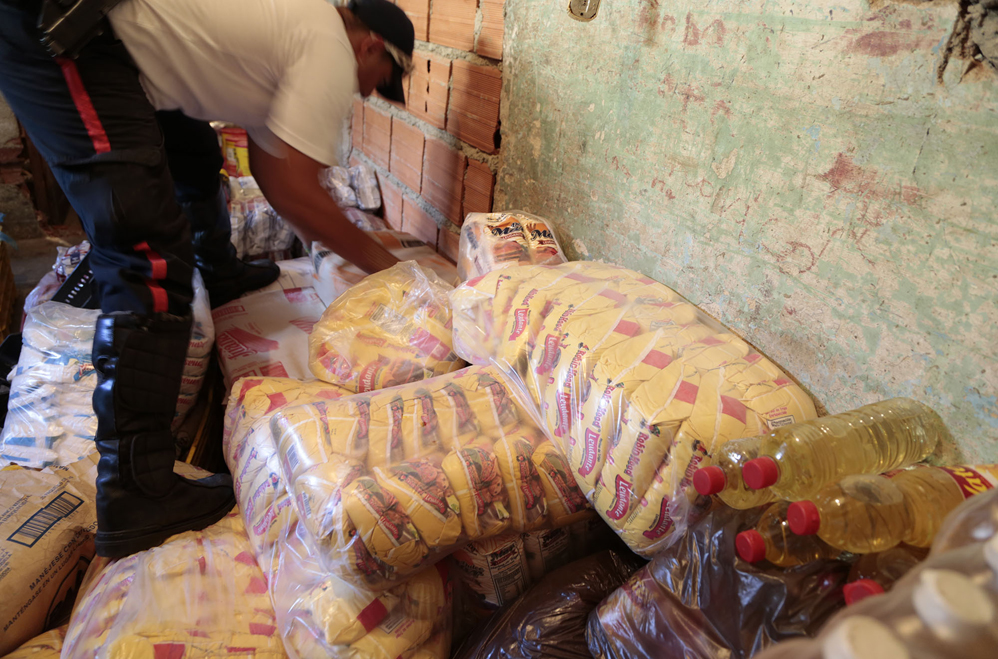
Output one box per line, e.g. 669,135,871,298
93,312,235,558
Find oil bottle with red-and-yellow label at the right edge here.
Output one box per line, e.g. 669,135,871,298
787,465,998,554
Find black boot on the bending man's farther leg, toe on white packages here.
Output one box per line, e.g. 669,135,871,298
181,188,281,309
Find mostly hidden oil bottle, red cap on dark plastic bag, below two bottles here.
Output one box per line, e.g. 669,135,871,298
735,501,842,567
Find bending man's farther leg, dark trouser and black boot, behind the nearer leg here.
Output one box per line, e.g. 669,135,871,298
156,110,281,308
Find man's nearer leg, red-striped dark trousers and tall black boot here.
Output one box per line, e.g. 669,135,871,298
0,0,235,557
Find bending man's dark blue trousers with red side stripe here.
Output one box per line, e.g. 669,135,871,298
0,0,229,315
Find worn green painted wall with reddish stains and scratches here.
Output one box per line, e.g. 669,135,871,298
496,0,998,462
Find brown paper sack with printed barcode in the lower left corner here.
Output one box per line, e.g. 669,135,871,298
0,454,97,656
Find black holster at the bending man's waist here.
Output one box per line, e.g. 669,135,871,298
38,0,122,58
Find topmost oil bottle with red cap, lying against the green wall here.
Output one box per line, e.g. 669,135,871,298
742,398,948,500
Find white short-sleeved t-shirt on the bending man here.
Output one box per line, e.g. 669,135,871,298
109,0,358,165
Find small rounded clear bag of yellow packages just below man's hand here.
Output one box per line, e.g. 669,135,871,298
309,261,464,393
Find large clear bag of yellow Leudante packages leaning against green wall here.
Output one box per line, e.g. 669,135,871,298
451,263,816,556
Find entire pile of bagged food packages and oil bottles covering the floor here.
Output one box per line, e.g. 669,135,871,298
0,165,998,659
